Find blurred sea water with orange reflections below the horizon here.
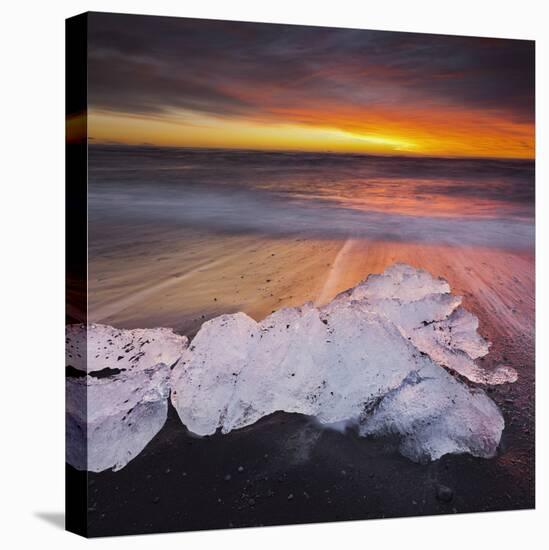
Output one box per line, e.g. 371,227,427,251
88,145,534,249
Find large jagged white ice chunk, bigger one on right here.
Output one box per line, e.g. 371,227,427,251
171,264,510,460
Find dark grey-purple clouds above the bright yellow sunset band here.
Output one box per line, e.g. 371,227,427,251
89,13,534,122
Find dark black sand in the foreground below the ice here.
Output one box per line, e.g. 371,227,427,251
73,366,535,537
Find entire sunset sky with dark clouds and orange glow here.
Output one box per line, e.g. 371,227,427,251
88,14,535,158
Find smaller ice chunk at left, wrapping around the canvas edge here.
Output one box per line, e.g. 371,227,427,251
66,325,187,472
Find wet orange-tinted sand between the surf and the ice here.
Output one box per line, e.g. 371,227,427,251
89,233,534,338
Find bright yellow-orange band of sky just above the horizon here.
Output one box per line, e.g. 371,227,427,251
88,109,534,158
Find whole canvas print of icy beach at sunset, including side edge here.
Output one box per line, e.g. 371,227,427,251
65,13,535,536
